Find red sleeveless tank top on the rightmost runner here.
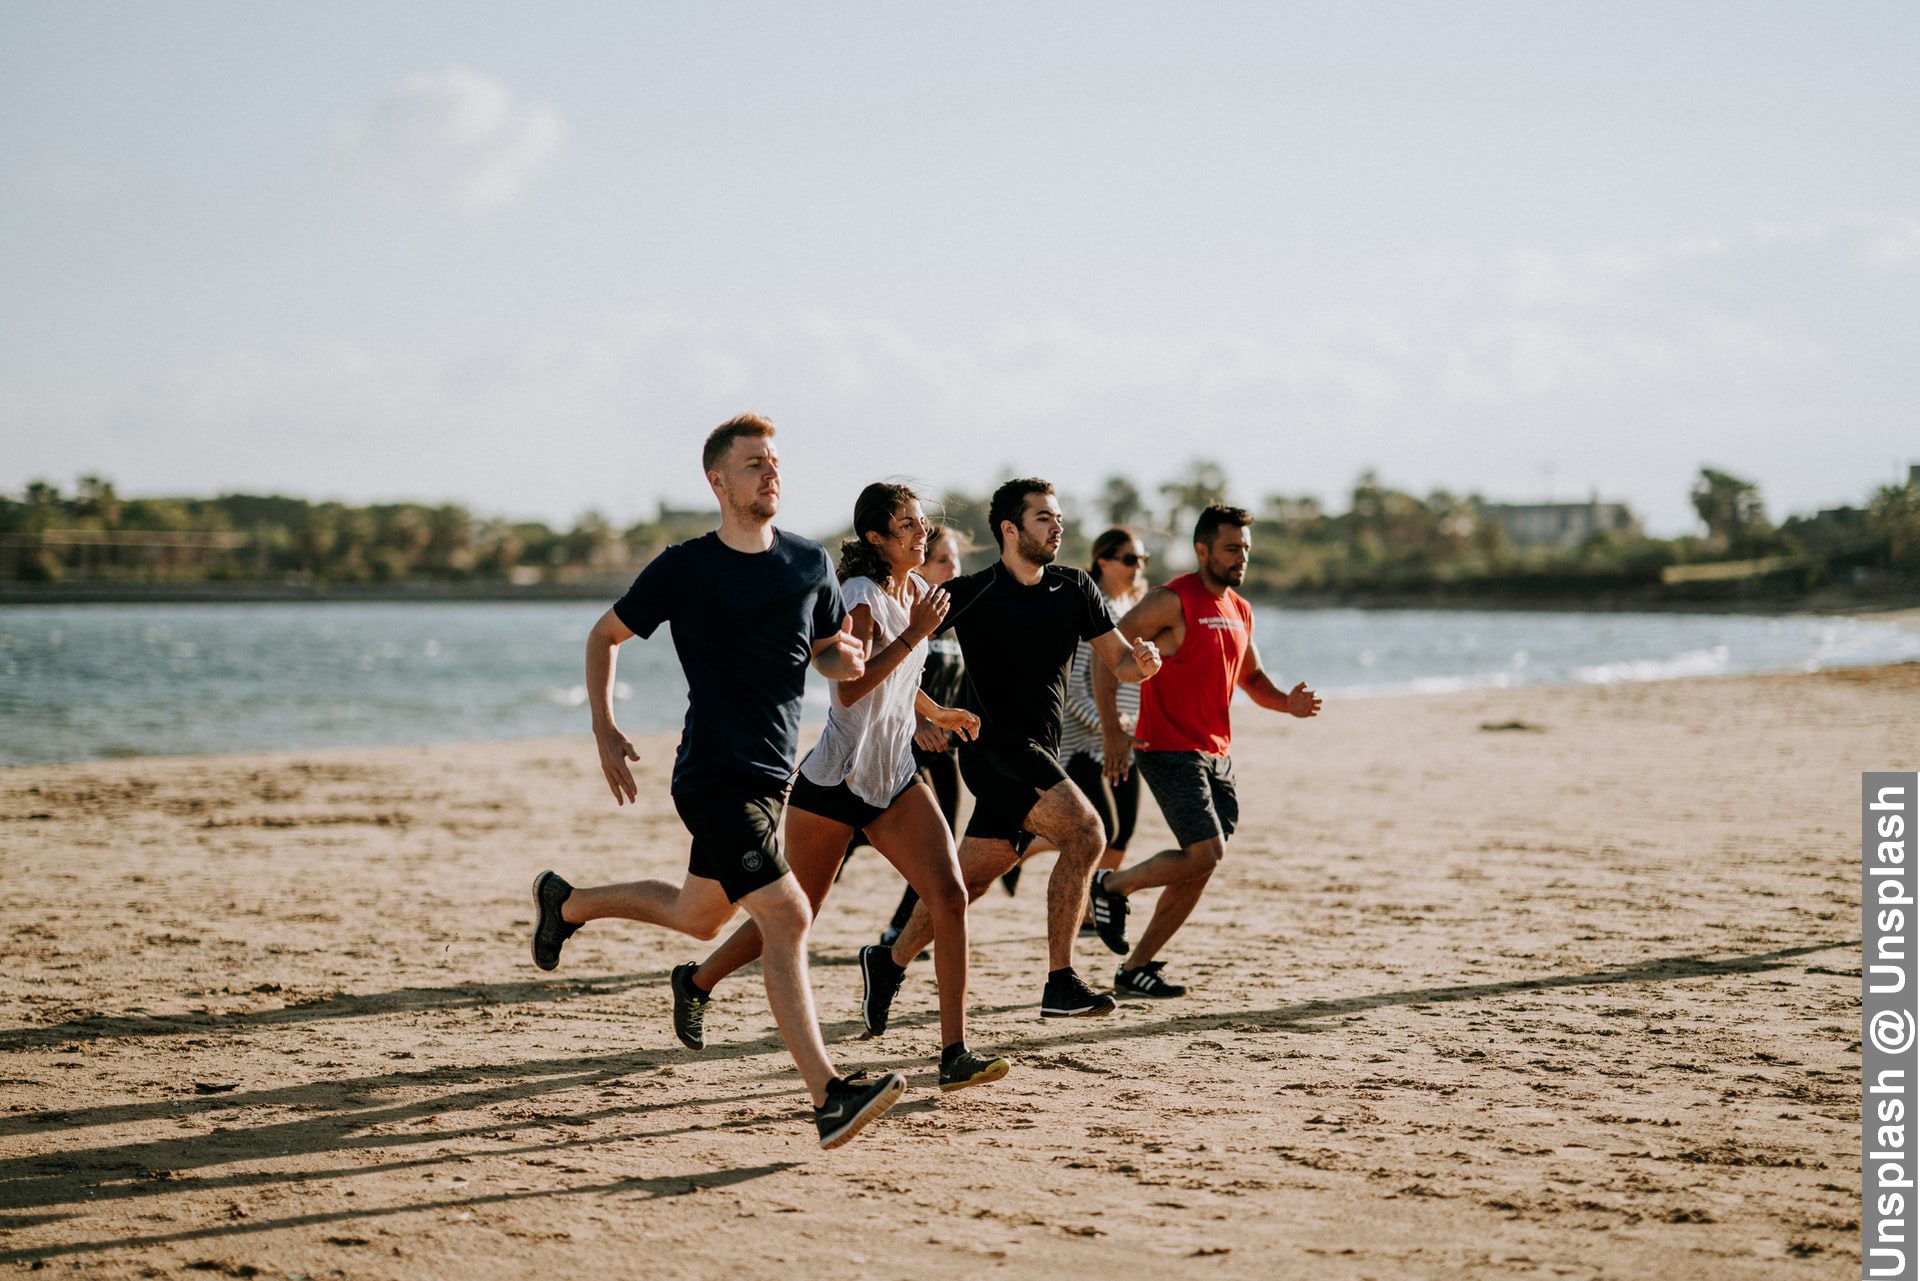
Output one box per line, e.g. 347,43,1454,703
1133,574,1254,757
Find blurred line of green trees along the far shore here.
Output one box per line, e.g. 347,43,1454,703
0,461,1920,593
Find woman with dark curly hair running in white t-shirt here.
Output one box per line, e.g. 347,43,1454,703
672,484,1010,1089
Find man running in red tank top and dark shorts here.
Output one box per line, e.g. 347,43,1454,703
1091,505,1321,997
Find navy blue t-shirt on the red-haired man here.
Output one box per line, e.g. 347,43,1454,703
612,530,847,795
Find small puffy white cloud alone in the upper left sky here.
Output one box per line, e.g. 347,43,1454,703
342,67,564,209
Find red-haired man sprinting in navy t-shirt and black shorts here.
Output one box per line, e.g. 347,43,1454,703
534,415,906,1147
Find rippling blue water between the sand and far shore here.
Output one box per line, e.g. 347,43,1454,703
0,603,1920,764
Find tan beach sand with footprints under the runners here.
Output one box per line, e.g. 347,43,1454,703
0,665,1920,1281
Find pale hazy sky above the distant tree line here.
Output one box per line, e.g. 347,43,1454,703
0,0,1920,534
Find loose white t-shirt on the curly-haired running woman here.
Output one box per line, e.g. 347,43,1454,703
801,574,927,805
